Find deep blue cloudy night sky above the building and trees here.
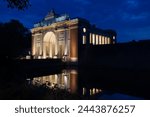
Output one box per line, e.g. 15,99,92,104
0,0,150,42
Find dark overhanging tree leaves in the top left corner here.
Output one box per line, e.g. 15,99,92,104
4,0,30,10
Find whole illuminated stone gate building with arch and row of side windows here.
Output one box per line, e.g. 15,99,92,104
31,10,116,62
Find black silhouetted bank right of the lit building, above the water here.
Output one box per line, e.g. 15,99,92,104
79,40,150,70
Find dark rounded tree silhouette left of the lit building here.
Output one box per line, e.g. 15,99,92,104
0,20,31,59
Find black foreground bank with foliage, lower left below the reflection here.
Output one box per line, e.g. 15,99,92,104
0,81,82,100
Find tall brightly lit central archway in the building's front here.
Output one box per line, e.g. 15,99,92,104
43,32,58,58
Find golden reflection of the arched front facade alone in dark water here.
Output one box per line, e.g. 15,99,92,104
32,70,78,93
